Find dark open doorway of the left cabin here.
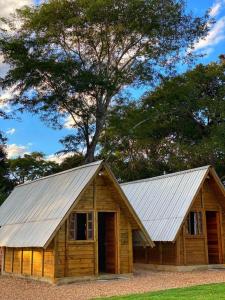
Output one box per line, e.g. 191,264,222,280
98,212,116,274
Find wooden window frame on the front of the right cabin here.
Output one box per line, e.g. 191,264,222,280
186,210,204,238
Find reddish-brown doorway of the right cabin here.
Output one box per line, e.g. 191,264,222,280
206,211,221,264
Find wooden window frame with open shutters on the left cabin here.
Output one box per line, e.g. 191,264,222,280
67,211,95,243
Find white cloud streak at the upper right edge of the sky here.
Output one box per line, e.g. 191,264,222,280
194,17,225,51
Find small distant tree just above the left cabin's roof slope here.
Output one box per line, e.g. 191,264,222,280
9,152,59,184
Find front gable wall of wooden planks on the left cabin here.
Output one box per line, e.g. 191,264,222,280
55,176,134,278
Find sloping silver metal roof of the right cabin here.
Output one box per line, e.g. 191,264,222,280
121,166,210,241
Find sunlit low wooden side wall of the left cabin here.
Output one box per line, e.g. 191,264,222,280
3,243,54,279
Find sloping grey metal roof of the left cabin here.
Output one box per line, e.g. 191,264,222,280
0,161,102,247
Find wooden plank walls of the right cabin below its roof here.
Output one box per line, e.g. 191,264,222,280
134,178,225,265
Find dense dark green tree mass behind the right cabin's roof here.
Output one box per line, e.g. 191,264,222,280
102,60,225,180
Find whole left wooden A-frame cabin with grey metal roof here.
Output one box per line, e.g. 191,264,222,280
0,161,154,283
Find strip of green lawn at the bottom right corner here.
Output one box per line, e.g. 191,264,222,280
98,283,225,300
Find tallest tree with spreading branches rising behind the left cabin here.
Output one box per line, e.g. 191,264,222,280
0,0,209,162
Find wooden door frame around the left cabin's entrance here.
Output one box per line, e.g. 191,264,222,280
94,209,120,275
